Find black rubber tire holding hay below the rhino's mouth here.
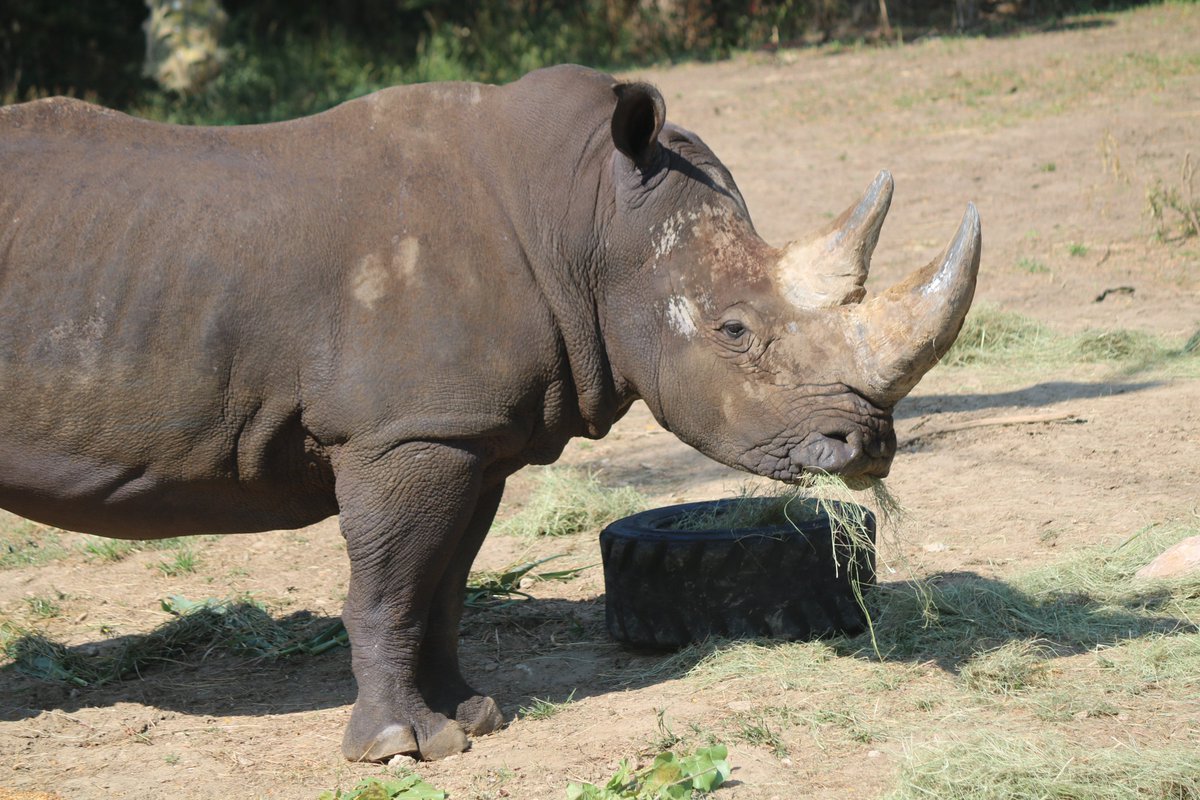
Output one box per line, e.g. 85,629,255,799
600,500,875,648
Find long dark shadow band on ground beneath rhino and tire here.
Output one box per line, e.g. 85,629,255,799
7,572,1198,721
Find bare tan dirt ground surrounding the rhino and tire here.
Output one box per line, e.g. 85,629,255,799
0,4,1200,800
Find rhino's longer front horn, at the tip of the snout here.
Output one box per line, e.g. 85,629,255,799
846,204,983,408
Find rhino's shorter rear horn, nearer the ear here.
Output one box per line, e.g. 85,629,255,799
779,169,894,308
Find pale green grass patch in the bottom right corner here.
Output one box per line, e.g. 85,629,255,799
887,733,1200,800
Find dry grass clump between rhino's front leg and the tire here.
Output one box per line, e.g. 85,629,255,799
494,468,648,536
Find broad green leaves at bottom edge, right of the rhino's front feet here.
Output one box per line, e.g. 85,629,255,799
566,745,730,800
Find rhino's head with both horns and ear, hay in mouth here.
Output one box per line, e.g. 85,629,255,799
605,84,980,481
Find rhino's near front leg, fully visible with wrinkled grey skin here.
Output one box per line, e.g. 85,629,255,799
337,443,481,760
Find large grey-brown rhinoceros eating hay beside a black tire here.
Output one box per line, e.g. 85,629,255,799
0,66,980,759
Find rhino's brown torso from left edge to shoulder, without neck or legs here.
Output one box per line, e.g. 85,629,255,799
0,90,568,536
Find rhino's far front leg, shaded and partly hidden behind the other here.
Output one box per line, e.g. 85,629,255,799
418,482,504,735
